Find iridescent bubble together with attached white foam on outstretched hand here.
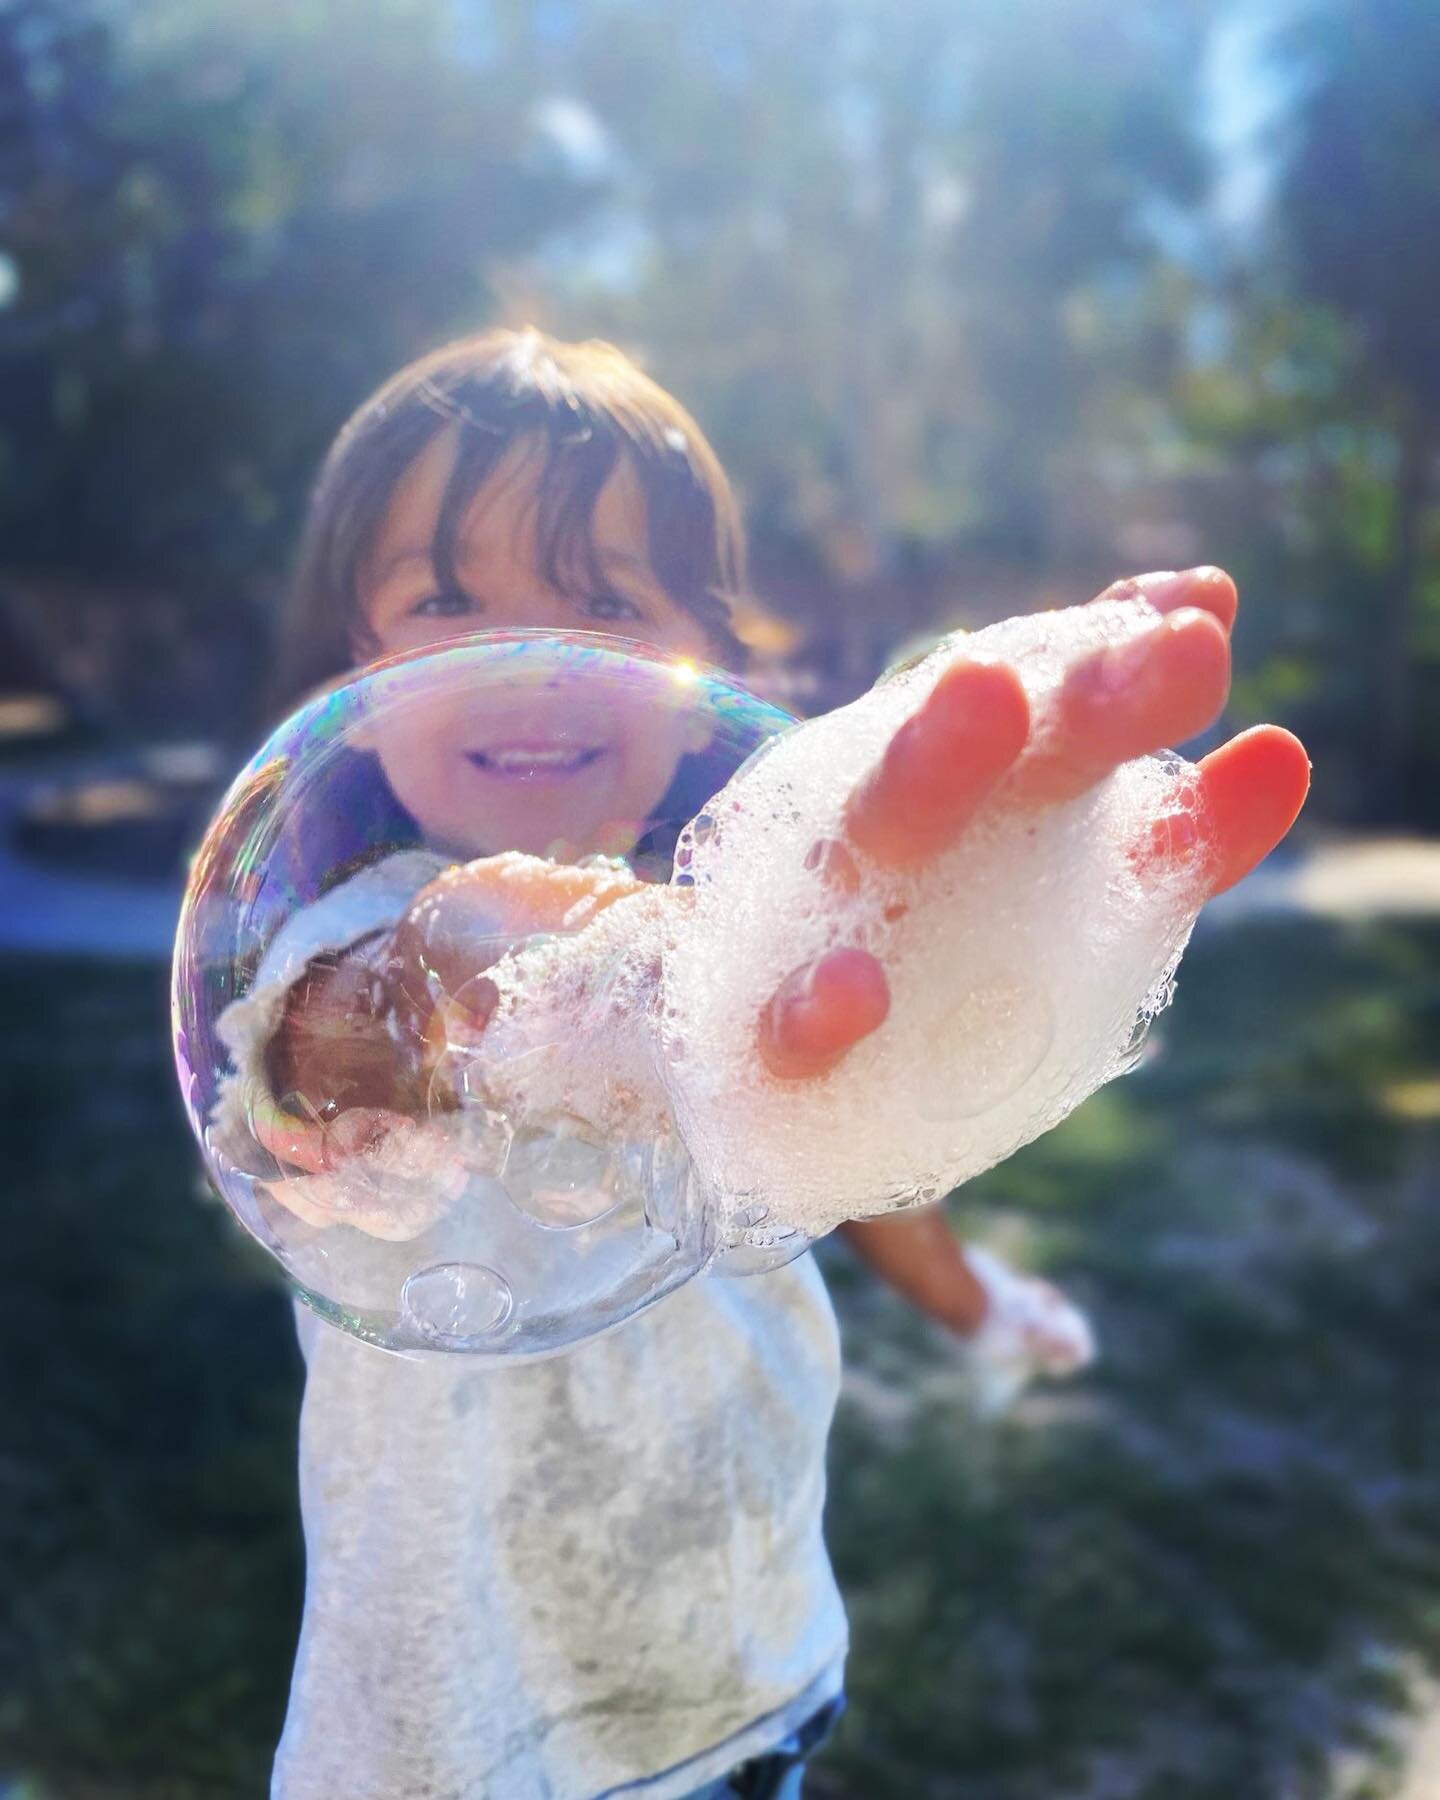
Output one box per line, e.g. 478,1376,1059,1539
175,601,1206,1355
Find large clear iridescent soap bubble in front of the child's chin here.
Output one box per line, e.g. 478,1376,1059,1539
173,634,803,1355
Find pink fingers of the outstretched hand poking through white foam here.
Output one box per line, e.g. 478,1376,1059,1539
758,569,1310,1080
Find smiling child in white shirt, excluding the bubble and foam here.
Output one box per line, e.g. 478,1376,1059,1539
259,333,1303,1800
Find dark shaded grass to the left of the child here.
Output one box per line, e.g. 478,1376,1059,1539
0,963,300,1800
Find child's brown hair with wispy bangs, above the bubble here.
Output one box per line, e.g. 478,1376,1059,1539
275,328,745,706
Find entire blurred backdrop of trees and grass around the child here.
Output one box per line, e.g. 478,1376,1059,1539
0,0,1440,1800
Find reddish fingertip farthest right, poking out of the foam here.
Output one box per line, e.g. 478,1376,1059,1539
1145,725,1310,898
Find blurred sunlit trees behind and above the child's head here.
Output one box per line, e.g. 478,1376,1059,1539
0,0,1440,823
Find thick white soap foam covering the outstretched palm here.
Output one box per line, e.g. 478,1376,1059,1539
661,599,1202,1237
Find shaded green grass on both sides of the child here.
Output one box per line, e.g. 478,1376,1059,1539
0,922,1440,1800
